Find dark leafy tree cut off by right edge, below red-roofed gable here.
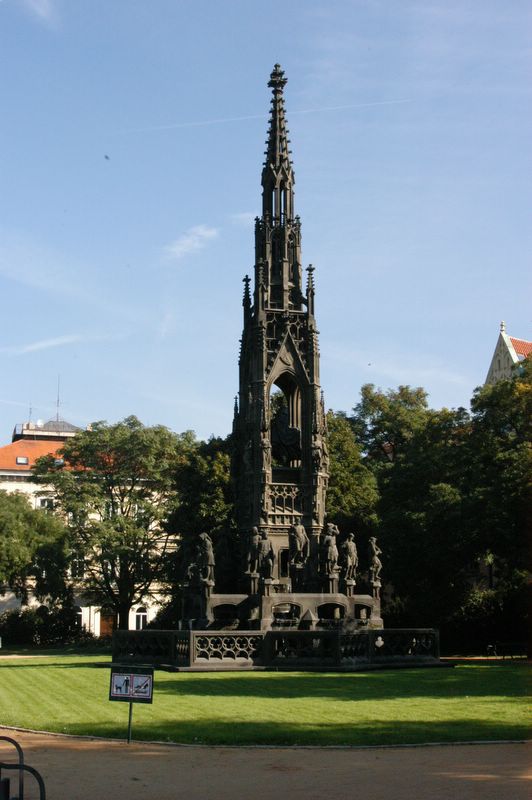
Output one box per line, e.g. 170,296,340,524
462,359,532,641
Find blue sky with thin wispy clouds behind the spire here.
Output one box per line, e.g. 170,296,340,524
0,0,532,443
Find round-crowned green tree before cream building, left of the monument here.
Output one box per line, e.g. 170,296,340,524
34,416,183,628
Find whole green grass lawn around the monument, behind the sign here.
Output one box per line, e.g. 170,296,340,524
0,654,528,745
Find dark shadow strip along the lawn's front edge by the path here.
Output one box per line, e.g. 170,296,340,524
61,714,529,747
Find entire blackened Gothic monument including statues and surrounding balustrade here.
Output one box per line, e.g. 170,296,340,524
114,64,438,669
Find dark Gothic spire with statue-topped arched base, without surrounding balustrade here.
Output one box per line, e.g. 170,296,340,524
200,64,382,630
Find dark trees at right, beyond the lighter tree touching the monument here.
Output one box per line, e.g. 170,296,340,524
351,364,532,649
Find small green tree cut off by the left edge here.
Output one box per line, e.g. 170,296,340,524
0,491,67,601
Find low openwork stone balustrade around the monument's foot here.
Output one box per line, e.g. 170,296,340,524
113,628,440,670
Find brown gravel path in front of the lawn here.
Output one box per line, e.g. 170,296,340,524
0,728,532,800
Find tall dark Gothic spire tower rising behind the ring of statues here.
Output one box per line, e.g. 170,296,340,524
233,64,329,591
